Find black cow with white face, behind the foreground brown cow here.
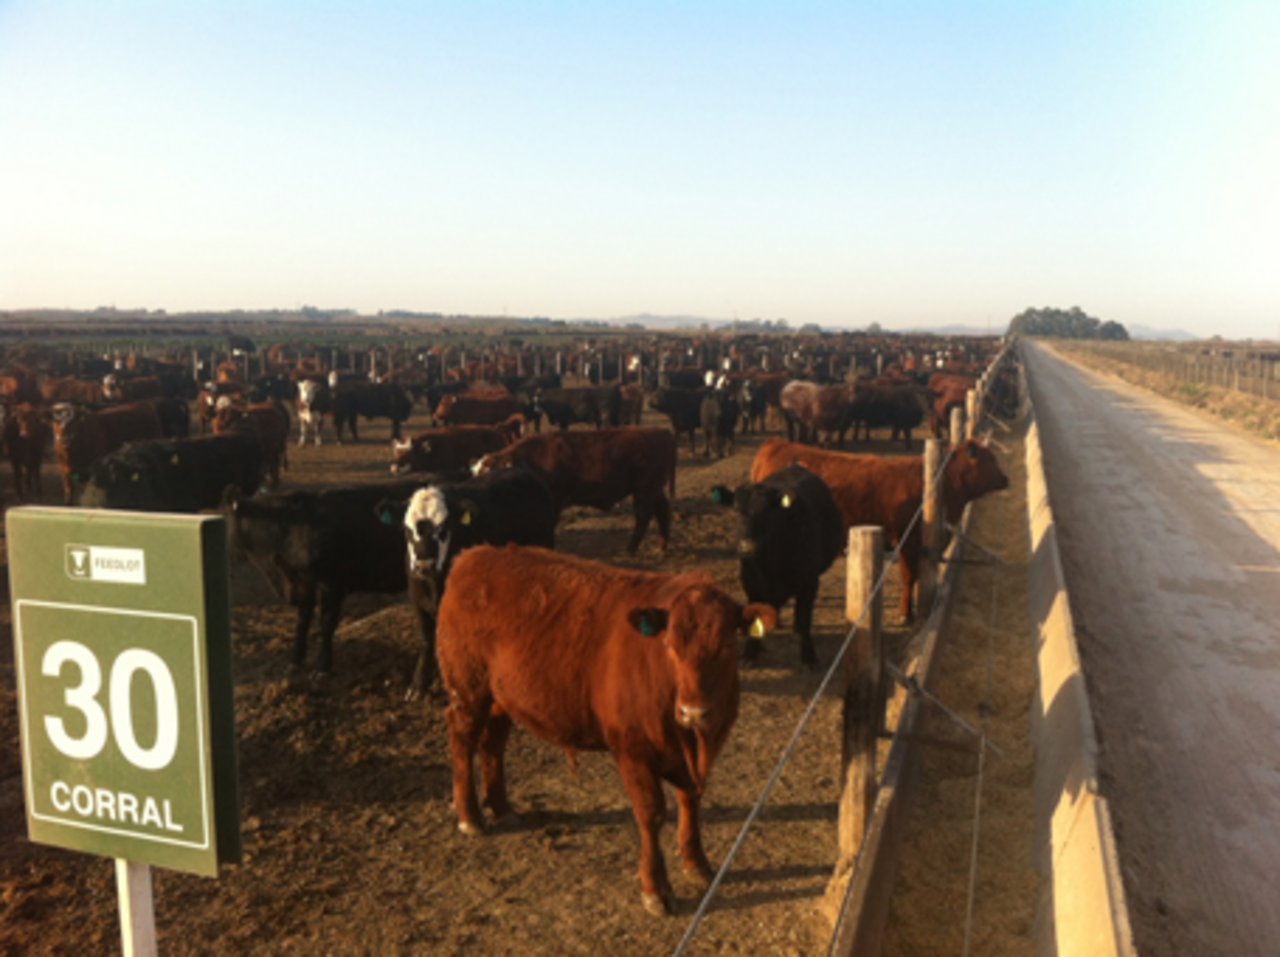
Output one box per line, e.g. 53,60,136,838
378,467,558,700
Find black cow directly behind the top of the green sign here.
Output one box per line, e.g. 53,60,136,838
79,432,265,512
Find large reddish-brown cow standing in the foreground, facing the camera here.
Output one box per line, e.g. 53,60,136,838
436,545,777,915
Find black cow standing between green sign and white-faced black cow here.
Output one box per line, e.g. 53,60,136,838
223,476,422,674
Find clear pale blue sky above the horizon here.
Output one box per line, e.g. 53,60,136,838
0,0,1280,338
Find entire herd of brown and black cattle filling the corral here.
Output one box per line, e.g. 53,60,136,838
0,335,1014,914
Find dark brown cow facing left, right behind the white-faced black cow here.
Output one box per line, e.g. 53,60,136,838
476,429,676,551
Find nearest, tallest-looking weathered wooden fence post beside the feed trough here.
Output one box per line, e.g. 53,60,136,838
836,525,884,876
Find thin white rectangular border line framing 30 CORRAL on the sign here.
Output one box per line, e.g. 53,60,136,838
13,599,212,851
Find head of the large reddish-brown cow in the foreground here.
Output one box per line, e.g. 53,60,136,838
627,574,777,792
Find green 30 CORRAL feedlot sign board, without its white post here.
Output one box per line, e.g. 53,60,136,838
6,508,239,876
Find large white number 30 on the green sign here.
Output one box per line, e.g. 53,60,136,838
41,641,178,771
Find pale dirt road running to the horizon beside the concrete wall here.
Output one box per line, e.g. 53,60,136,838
1025,345,1280,954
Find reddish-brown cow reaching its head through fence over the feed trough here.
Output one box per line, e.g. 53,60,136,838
751,439,1009,621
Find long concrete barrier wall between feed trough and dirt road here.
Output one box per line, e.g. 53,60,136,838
1023,355,1135,957
